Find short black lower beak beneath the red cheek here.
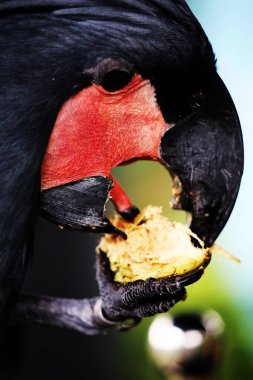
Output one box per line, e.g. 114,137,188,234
40,176,123,234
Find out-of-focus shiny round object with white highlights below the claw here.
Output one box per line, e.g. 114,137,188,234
148,310,224,380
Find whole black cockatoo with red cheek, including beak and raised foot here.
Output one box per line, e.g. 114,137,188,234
0,0,243,333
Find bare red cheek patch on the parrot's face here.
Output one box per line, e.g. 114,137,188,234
41,75,168,194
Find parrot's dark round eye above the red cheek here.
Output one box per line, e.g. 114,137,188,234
101,69,132,92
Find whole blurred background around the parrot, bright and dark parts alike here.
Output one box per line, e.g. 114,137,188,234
15,0,253,380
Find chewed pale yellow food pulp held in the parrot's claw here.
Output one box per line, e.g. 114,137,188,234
97,206,211,283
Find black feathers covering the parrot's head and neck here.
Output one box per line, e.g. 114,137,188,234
0,0,242,336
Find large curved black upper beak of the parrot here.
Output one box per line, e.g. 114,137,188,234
160,74,243,246
